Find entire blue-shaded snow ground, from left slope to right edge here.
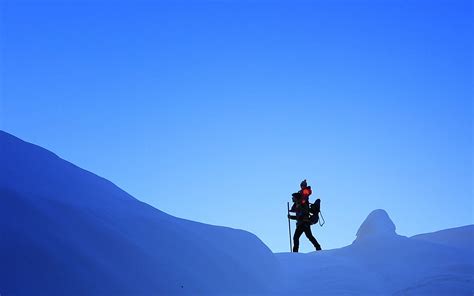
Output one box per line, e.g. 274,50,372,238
0,131,474,296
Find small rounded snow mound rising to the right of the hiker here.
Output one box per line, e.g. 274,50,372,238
356,209,397,240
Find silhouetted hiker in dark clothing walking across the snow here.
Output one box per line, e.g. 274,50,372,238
288,180,321,253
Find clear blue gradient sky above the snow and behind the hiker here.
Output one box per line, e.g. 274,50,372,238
0,0,474,252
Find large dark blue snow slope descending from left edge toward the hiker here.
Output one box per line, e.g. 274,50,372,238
0,131,277,296
